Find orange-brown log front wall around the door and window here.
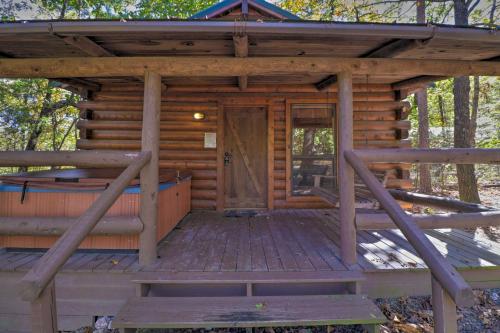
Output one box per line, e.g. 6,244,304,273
77,84,411,209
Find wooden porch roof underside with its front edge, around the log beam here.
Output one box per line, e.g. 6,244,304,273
0,21,500,85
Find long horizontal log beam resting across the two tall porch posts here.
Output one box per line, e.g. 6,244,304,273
0,56,500,78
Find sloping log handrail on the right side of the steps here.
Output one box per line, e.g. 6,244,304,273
344,151,474,306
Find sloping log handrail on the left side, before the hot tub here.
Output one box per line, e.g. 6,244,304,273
21,152,151,301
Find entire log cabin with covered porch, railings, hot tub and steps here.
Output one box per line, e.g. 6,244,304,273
0,0,500,332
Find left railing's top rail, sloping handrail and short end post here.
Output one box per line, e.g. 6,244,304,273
0,151,151,333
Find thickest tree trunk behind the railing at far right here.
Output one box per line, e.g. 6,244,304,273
453,0,480,203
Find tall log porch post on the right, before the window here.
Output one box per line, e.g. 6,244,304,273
334,72,356,265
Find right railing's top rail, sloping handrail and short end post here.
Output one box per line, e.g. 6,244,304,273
344,148,500,332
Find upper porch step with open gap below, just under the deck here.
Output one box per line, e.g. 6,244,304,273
132,270,365,297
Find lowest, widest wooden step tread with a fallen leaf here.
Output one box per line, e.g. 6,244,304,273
113,295,386,331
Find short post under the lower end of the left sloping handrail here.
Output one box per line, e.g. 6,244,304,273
31,279,58,333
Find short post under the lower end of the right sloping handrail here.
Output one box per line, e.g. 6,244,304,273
432,275,458,333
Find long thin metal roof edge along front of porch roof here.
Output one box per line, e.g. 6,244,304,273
0,20,500,43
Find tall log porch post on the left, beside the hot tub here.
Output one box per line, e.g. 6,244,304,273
139,71,161,266
